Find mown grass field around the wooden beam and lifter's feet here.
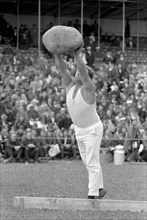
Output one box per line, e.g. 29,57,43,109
0,155,147,220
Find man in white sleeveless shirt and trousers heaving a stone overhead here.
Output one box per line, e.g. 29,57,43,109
55,47,106,199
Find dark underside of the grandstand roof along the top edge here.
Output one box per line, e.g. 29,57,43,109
0,0,147,20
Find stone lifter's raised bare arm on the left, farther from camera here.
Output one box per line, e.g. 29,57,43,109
55,54,73,88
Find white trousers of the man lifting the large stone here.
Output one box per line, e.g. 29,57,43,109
75,121,103,196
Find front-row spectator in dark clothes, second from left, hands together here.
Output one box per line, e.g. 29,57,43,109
21,129,41,163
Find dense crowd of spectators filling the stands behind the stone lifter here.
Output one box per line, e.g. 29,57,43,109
0,16,147,163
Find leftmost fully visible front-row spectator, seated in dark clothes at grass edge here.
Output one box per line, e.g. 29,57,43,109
4,132,23,163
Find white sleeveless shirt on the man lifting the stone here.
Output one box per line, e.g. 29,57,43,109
66,85,100,128
